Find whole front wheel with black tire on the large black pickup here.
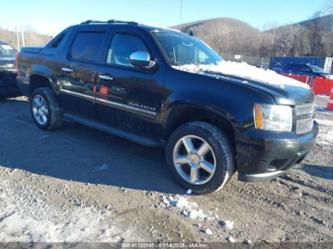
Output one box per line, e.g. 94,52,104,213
165,121,235,194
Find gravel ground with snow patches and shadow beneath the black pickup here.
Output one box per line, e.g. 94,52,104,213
0,97,333,244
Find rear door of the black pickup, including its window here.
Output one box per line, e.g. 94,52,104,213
57,28,106,119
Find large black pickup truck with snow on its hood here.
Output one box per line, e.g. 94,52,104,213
17,20,318,193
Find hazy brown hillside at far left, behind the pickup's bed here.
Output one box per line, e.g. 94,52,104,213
0,28,52,49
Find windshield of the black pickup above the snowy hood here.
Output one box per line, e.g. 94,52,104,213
152,30,223,66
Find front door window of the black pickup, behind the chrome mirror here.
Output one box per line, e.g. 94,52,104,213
106,34,149,67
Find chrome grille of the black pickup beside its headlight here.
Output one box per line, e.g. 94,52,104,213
295,103,314,134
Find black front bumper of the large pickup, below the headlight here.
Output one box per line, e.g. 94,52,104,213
236,122,319,182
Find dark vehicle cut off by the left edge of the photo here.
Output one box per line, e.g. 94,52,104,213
0,41,19,99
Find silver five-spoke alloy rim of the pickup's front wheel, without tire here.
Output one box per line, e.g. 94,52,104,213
173,135,216,185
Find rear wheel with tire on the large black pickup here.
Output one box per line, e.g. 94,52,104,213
30,87,63,130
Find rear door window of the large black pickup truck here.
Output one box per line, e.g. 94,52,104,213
70,32,105,62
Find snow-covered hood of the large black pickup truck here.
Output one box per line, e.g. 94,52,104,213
174,61,313,106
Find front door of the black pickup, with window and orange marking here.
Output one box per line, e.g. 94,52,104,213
96,28,166,138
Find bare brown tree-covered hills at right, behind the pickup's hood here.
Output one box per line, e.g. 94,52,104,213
174,15,333,57
